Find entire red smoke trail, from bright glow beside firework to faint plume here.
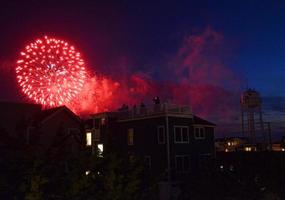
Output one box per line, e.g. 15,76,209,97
71,28,240,122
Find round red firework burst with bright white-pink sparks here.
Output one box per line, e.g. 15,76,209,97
16,36,86,106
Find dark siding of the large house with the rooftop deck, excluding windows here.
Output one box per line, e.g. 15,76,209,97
87,115,215,178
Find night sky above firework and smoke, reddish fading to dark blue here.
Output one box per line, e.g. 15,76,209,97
0,0,285,96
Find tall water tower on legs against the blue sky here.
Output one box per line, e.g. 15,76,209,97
240,89,265,144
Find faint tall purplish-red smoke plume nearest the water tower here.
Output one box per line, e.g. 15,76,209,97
166,28,240,118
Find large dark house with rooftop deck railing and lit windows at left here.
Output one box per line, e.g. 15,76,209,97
86,102,215,180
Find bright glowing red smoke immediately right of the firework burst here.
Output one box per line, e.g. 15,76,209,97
67,71,155,116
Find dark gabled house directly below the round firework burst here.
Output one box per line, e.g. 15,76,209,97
32,106,83,153
